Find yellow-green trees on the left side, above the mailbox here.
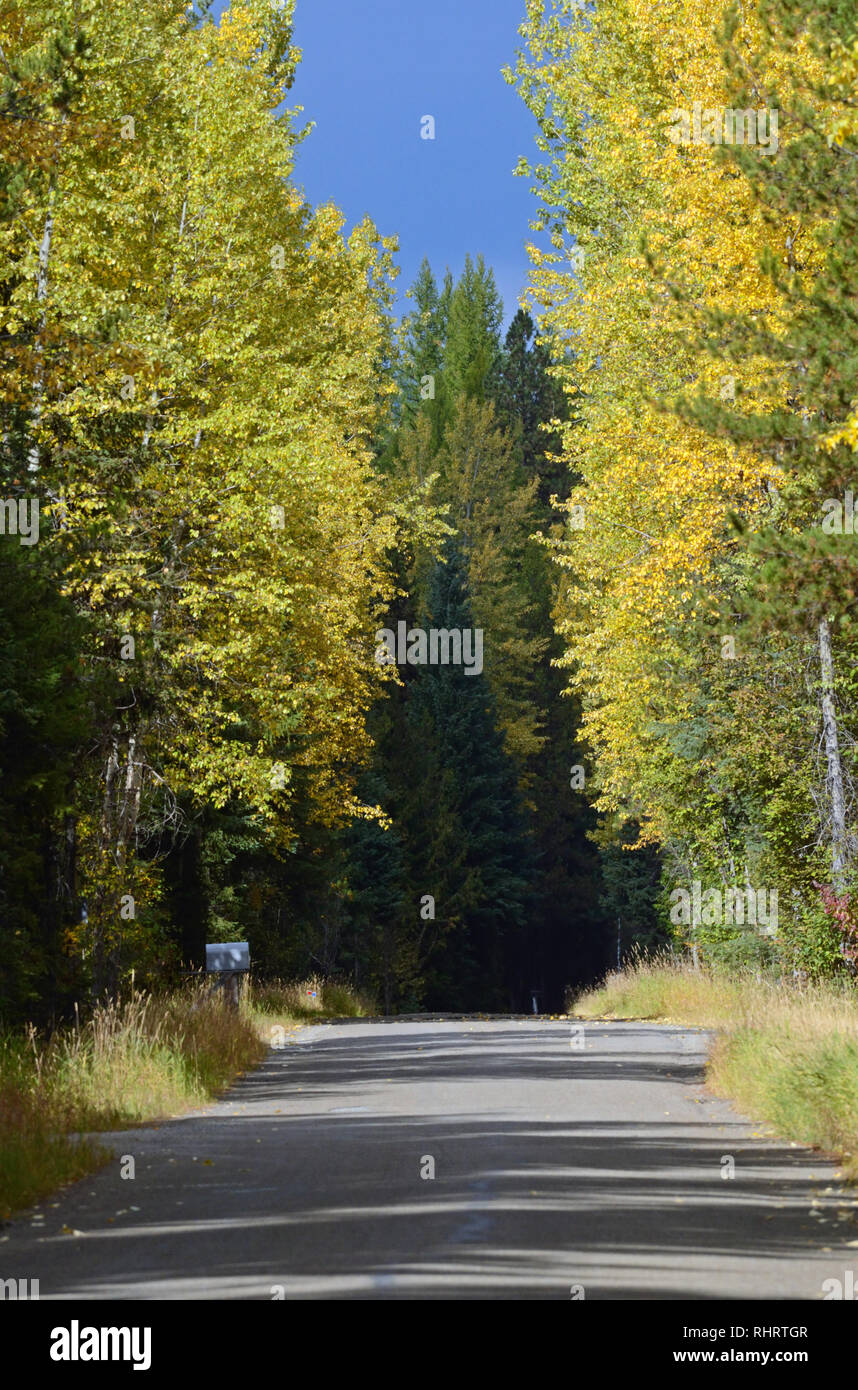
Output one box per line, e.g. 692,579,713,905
0,0,400,1015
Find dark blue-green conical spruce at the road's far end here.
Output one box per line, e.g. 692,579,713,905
399,542,533,1009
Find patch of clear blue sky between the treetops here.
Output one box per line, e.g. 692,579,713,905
222,0,535,322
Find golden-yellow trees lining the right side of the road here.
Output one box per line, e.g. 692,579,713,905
505,0,858,974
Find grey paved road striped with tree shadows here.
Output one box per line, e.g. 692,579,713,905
0,1019,858,1300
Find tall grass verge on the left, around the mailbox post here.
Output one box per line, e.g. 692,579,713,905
0,980,370,1219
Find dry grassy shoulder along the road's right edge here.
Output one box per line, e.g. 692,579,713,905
570,962,858,1182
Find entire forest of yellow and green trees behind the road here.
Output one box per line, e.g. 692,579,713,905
0,0,858,1024
